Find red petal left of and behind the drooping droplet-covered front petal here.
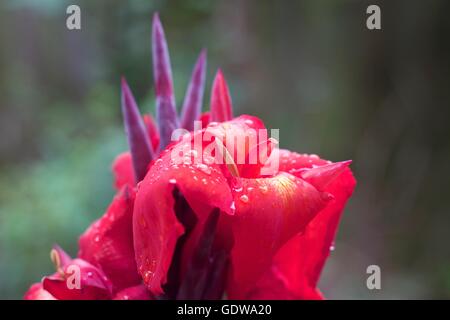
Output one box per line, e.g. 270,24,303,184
78,186,141,291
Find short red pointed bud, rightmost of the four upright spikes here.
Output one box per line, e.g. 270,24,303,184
211,69,233,122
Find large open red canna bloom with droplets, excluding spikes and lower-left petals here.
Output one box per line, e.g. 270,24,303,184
133,116,354,298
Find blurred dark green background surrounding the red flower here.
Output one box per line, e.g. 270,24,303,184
0,0,450,299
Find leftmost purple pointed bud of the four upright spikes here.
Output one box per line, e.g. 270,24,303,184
122,78,153,182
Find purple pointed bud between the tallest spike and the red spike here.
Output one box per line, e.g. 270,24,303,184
181,50,206,131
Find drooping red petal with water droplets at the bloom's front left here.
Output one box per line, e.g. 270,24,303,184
133,139,232,295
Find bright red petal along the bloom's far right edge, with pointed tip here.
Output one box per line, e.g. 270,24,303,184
252,150,356,299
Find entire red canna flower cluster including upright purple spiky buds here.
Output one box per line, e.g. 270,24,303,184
25,15,355,299
